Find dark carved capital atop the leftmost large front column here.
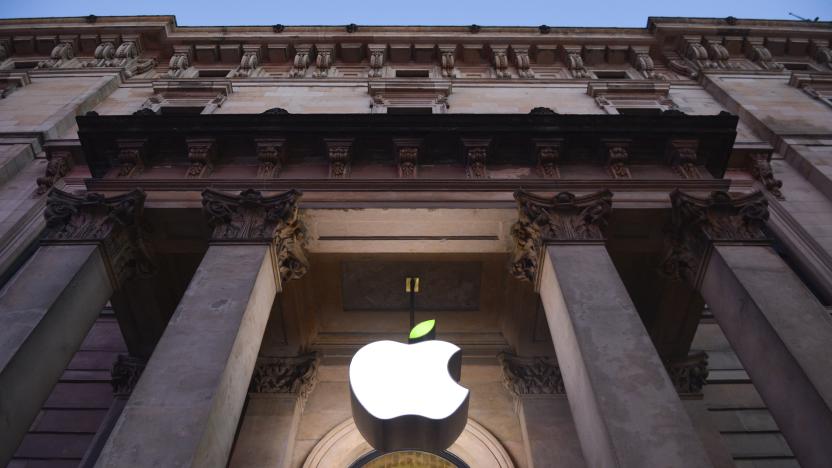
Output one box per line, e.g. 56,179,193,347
41,188,156,287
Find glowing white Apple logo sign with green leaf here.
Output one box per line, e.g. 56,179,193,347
349,320,468,452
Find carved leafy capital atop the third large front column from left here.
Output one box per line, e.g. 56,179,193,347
509,190,612,285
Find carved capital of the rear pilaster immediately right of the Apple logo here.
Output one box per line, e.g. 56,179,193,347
497,353,566,396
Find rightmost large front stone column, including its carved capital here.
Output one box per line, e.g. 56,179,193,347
665,190,832,467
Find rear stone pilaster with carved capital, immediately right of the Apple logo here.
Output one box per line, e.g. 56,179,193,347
498,353,586,468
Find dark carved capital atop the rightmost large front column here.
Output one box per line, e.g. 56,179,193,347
662,189,768,287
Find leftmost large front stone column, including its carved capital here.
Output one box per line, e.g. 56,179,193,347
0,189,150,465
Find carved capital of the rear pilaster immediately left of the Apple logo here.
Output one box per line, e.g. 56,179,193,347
249,352,321,402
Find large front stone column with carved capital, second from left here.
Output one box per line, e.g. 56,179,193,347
96,190,307,467
